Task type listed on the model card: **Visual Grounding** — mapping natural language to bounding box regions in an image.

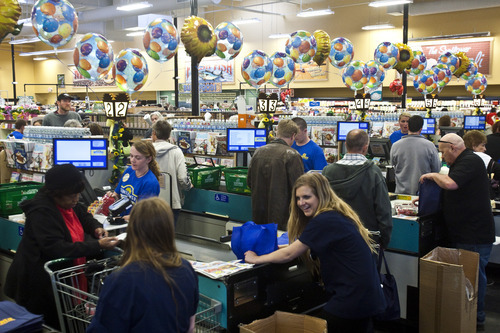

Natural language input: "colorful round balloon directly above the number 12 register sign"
[113,48,149,94]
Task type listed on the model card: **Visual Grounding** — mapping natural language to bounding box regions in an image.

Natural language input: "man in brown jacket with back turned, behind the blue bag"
[247,119,304,230]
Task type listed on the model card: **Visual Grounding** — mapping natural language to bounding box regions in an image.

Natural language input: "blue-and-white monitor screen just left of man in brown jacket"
[227,128,266,152]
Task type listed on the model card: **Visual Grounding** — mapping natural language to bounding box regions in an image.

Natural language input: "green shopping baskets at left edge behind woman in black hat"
[0,182,43,217]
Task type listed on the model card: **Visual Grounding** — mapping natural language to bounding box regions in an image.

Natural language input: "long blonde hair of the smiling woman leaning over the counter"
[287,173,376,272]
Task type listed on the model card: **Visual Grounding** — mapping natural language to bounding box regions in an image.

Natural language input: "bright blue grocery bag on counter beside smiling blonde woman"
[231,221,278,259]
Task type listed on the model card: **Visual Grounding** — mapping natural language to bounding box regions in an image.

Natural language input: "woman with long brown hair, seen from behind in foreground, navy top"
[87,198,199,333]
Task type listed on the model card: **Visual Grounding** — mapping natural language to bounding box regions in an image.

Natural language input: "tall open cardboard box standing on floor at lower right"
[419,247,479,333]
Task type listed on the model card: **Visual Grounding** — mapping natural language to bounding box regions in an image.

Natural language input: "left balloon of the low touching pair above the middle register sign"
[241,50,273,88]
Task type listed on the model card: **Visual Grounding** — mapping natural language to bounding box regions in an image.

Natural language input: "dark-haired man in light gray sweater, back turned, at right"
[391,116,441,195]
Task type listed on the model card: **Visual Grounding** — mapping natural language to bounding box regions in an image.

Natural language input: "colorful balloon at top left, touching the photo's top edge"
[31,0,78,48]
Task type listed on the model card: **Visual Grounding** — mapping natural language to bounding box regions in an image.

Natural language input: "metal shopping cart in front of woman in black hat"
[45,257,225,333]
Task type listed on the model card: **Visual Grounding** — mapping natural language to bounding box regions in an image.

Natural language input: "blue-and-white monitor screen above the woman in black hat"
[53,138,108,170]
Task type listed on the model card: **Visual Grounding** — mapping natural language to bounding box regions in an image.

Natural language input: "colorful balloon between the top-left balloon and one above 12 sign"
[73,33,114,81]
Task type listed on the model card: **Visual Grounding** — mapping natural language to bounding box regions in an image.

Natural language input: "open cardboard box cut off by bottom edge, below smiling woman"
[240,311,327,333]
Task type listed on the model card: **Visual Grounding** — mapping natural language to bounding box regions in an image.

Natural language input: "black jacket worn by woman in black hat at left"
[5,190,102,327]
